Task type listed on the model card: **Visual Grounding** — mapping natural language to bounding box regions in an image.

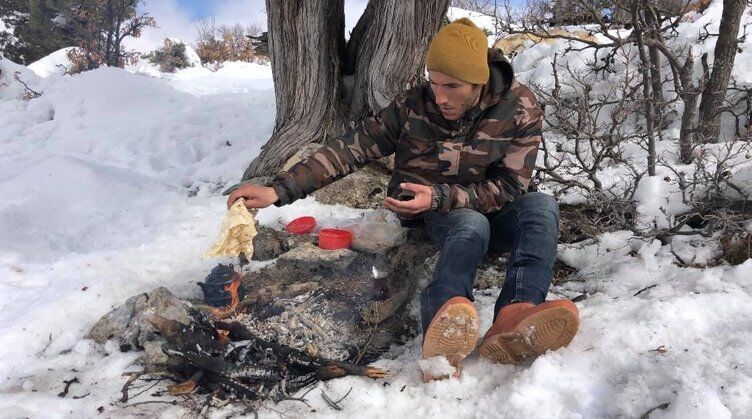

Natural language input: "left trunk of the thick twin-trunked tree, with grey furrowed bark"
[243,0,345,179]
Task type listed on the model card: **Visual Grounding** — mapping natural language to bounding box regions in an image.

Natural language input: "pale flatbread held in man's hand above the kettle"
[204,198,258,260]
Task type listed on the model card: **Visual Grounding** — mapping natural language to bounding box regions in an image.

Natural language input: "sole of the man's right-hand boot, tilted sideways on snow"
[478,307,580,364]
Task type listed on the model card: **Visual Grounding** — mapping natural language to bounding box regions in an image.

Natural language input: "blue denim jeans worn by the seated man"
[420,192,559,331]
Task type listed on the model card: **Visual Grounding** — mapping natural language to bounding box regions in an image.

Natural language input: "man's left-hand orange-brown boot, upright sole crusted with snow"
[420,297,478,382]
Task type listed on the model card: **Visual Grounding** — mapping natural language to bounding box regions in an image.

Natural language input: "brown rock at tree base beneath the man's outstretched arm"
[313,162,391,209]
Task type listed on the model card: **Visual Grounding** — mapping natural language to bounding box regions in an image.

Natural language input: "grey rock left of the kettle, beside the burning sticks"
[89,287,191,350]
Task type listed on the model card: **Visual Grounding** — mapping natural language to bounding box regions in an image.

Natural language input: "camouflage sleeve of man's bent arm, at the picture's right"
[431,92,543,213]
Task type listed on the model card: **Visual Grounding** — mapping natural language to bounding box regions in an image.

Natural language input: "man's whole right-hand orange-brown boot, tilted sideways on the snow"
[478,300,580,364]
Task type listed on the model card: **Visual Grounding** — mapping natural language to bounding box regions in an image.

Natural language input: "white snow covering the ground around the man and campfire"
[0,1,752,418]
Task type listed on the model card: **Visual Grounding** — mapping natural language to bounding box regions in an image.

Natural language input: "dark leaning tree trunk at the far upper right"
[698,0,747,142]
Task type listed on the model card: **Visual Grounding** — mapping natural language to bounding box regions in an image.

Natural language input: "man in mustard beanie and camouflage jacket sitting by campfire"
[227,18,579,381]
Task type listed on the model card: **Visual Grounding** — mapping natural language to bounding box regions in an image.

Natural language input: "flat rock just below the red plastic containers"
[277,243,357,275]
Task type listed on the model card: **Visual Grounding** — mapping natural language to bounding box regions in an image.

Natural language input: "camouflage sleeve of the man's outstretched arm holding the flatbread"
[270,95,407,206]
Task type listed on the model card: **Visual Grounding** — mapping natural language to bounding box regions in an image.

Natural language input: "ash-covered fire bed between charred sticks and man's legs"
[233,229,436,363]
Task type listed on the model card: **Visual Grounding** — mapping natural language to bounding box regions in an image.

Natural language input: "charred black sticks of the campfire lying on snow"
[150,312,386,401]
